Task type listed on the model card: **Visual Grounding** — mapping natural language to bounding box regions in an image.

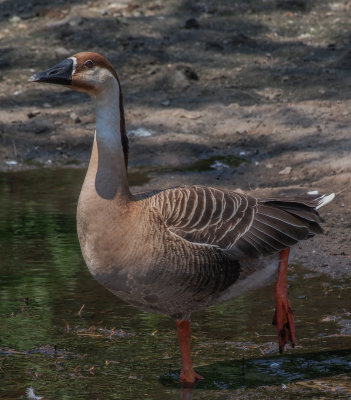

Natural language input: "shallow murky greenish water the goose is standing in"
[0,169,351,400]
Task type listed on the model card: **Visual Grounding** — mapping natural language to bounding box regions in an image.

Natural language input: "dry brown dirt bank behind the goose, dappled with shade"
[0,0,351,277]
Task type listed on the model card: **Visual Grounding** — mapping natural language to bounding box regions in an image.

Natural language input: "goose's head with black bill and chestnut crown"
[29,52,119,97]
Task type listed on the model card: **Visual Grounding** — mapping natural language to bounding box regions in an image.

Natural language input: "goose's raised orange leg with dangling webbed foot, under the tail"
[273,249,295,353]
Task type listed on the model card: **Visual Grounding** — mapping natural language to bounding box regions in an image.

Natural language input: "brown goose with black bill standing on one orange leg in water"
[29,52,334,384]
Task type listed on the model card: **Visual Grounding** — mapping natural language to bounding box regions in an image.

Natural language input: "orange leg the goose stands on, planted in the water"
[176,321,204,383]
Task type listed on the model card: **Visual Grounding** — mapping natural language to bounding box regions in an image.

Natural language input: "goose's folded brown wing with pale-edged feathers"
[150,186,322,259]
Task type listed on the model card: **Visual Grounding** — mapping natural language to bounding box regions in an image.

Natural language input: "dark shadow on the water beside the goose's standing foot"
[161,350,351,390]
